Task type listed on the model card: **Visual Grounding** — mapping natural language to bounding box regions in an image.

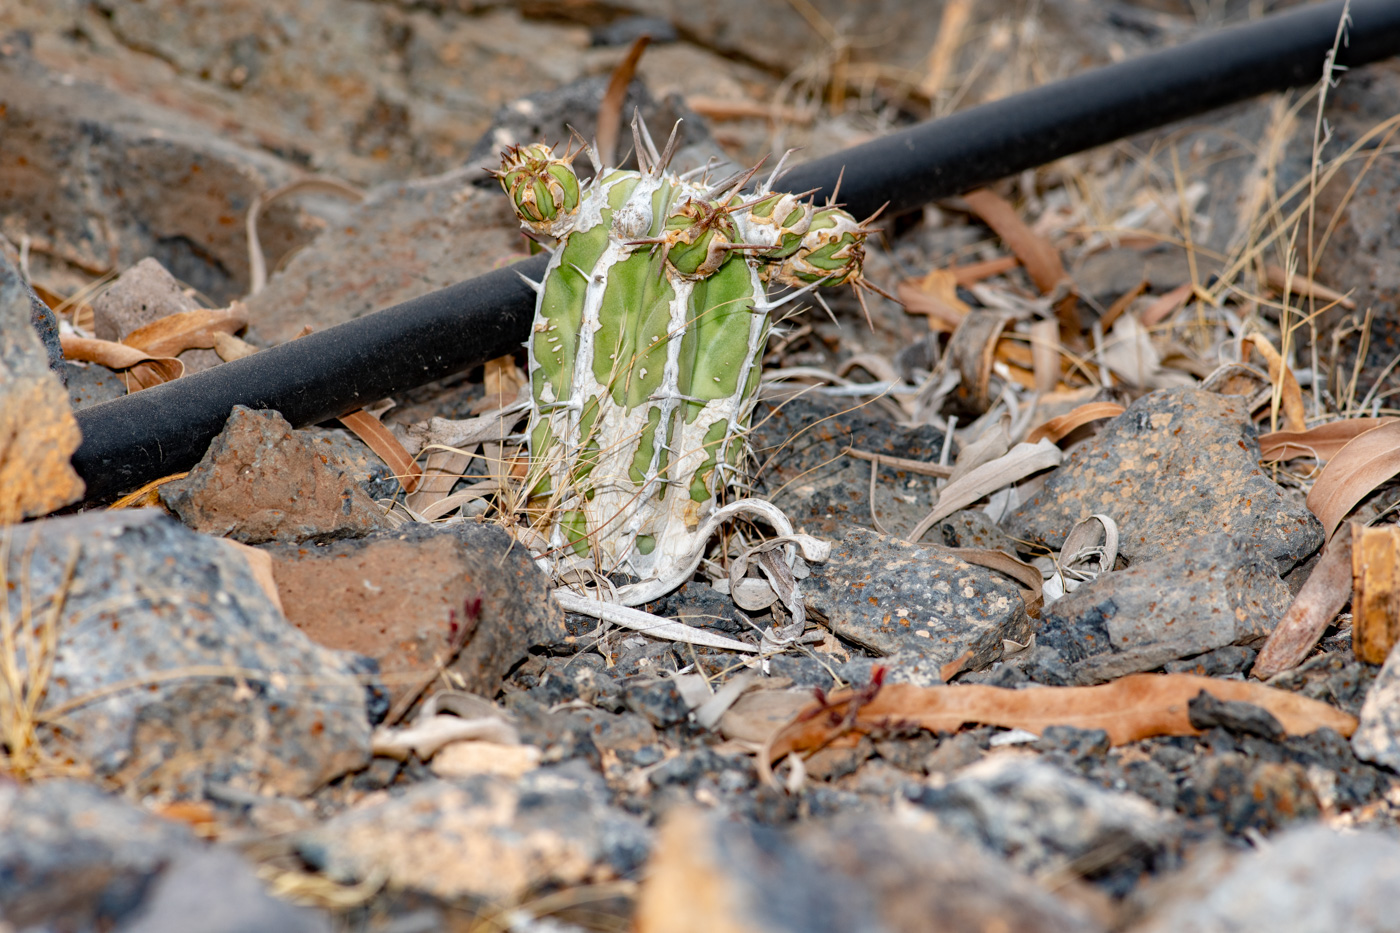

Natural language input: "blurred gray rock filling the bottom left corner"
[0,780,330,933]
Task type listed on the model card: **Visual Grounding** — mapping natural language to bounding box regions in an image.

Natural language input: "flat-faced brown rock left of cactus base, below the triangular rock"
[272,524,564,699]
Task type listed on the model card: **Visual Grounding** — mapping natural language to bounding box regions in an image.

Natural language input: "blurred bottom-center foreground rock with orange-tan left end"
[637,808,1102,933]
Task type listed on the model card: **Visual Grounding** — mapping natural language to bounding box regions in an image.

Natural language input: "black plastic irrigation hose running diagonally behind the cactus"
[73,0,1400,499]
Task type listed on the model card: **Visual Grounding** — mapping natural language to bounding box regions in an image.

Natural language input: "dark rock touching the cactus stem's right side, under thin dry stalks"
[749,395,944,537]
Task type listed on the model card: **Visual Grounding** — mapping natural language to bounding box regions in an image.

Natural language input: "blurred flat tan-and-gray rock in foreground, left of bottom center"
[294,762,650,904]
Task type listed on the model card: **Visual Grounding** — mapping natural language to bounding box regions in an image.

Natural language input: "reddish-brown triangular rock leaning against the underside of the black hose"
[161,405,388,544]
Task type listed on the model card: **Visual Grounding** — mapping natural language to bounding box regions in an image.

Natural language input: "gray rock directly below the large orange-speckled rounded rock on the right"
[1032,534,1291,684]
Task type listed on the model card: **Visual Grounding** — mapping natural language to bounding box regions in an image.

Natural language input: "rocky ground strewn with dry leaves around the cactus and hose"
[0,0,1400,933]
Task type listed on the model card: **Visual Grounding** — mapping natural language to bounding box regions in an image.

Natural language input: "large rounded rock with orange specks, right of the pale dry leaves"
[1005,388,1322,572]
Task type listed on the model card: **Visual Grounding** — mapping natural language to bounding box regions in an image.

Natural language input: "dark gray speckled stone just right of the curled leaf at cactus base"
[804,528,1030,671]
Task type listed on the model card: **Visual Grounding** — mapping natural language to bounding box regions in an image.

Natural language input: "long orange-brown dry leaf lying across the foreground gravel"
[759,674,1357,786]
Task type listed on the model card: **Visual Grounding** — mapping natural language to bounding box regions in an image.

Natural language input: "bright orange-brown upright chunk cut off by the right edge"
[1330,525,1400,664]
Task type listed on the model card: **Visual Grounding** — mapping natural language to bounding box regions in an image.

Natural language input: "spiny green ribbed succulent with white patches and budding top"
[497,123,868,605]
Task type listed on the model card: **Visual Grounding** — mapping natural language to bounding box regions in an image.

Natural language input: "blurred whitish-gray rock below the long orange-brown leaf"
[913,755,1180,892]
